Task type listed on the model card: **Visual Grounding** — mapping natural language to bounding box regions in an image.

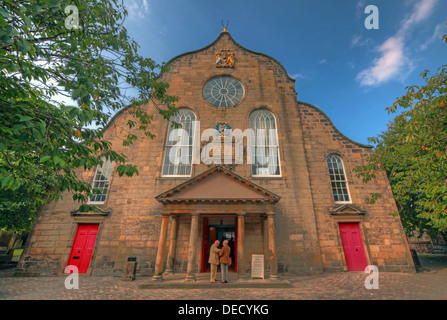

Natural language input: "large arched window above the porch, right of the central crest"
[250,110,281,176]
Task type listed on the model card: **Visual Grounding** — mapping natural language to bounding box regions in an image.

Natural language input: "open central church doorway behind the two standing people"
[201,218,237,272]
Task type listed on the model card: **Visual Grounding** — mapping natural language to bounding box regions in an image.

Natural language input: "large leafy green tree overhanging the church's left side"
[0,0,178,229]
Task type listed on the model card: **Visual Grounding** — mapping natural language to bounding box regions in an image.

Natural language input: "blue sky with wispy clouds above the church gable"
[124,0,447,143]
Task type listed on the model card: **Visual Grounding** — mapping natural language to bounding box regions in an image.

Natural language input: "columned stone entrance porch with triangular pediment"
[153,166,280,282]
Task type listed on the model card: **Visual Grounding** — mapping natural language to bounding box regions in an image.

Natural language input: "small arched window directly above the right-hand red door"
[327,154,351,203]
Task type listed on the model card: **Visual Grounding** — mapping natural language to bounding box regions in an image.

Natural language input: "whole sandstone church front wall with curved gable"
[17,31,414,276]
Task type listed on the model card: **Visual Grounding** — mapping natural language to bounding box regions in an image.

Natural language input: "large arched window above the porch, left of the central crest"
[162,109,196,176]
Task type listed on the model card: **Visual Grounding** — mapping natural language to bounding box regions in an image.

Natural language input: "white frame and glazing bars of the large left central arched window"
[161,108,197,178]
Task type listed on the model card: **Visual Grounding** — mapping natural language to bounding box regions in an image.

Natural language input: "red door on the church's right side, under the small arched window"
[339,223,368,271]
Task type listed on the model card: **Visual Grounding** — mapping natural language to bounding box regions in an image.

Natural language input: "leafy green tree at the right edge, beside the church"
[355,30,447,236]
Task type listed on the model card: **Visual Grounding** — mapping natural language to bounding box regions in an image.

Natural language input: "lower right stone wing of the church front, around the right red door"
[299,103,414,272]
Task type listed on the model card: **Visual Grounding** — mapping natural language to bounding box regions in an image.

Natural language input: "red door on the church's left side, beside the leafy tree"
[68,224,99,273]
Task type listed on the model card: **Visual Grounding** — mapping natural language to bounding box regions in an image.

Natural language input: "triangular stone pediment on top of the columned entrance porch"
[155,165,281,203]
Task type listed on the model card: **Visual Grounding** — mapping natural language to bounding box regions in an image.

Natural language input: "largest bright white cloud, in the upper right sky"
[351,0,439,86]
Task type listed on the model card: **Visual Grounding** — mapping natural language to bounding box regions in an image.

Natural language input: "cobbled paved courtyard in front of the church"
[0,257,447,300]
